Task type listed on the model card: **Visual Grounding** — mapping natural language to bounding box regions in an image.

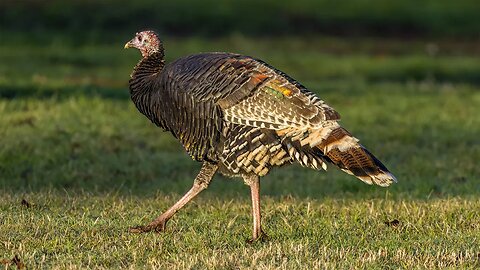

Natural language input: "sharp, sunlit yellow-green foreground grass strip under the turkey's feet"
[0,191,480,269]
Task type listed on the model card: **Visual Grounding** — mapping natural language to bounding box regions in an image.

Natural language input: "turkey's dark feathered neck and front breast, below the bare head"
[129,49,170,130]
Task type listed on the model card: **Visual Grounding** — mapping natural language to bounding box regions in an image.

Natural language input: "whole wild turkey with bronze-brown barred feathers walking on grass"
[125,31,396,241]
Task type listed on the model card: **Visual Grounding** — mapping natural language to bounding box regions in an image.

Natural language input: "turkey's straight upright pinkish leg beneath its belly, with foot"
[243,175,266,243]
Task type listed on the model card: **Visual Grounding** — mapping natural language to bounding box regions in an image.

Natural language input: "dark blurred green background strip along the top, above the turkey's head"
[0,0,480,41]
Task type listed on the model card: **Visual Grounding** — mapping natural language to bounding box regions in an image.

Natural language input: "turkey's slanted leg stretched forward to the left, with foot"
[130,162,218,233]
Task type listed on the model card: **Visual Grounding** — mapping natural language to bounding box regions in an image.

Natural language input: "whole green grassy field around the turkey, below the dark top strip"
[0,37,480,269]
